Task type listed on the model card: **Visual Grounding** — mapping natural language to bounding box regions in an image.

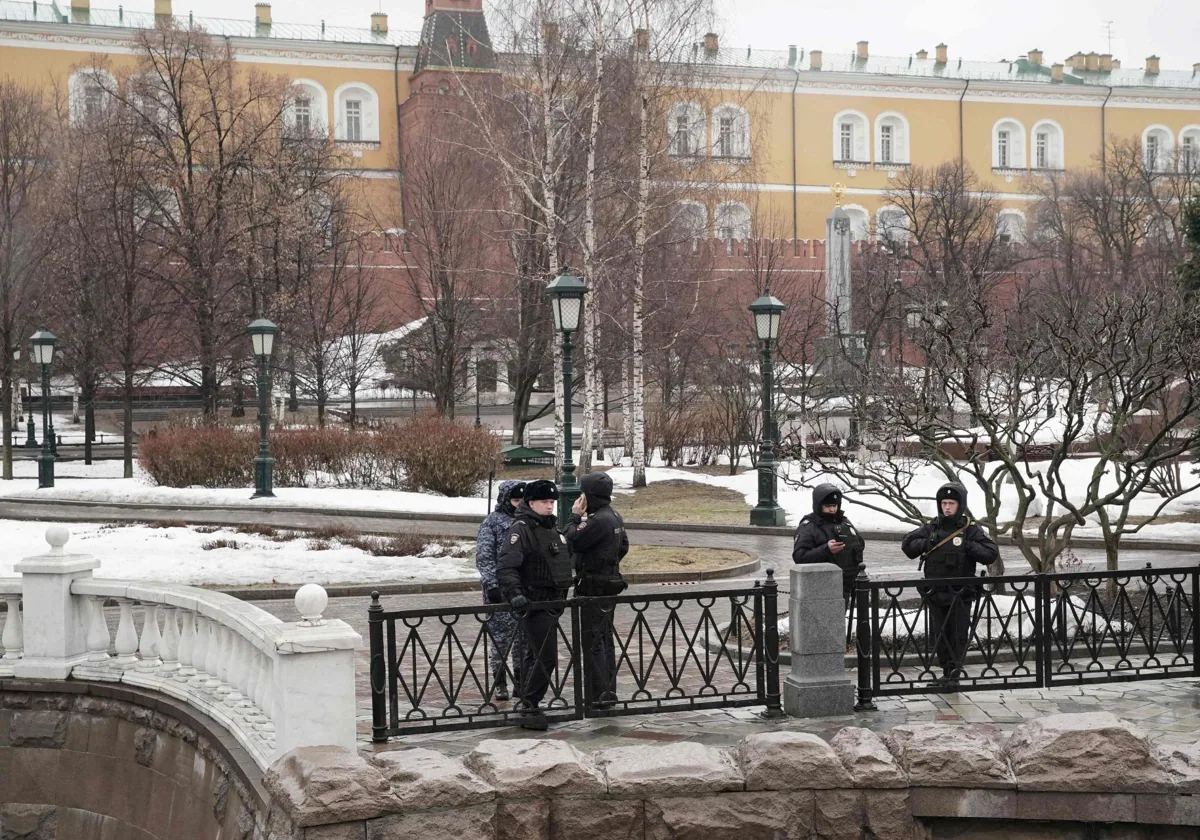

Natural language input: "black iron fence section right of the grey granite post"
[847,565,1200,708]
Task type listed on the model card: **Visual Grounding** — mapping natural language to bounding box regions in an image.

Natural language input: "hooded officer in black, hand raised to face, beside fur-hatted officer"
[563,473,629,709]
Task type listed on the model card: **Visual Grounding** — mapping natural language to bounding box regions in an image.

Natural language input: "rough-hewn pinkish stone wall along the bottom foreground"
[264,713,1200,840]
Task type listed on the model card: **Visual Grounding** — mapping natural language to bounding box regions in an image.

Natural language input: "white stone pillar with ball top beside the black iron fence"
[265,583,362,758]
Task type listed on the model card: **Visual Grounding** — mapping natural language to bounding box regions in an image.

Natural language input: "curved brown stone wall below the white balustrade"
[0,680,290,840]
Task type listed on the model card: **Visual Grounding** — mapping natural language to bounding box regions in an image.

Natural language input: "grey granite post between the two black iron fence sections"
[784,563,854,718]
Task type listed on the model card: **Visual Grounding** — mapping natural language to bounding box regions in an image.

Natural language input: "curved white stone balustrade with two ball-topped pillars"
[0,526,362,768]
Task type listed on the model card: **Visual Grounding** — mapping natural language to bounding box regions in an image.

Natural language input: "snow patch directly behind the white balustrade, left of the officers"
[0,521,479,586]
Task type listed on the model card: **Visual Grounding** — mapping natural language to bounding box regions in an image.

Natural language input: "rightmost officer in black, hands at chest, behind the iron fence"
[901,481,1000,689]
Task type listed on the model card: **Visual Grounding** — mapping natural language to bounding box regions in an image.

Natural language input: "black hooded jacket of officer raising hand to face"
[563,473,629,595]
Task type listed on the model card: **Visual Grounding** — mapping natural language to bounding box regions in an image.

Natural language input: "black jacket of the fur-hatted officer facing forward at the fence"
[496,499,571,601]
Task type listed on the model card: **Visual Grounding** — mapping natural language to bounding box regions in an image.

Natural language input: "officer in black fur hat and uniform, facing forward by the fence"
[496,479,571,730]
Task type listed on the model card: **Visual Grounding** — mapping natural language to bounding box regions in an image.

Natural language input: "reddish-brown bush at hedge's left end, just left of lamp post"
[138,425,258,487]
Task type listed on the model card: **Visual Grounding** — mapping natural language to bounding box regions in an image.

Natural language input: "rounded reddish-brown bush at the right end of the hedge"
[392,415,500,496]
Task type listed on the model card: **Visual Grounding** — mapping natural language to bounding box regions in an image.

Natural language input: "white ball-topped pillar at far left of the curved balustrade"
[13,526,100,679]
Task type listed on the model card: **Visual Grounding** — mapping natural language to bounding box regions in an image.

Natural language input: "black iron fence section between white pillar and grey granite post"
[368,570,781,742]
